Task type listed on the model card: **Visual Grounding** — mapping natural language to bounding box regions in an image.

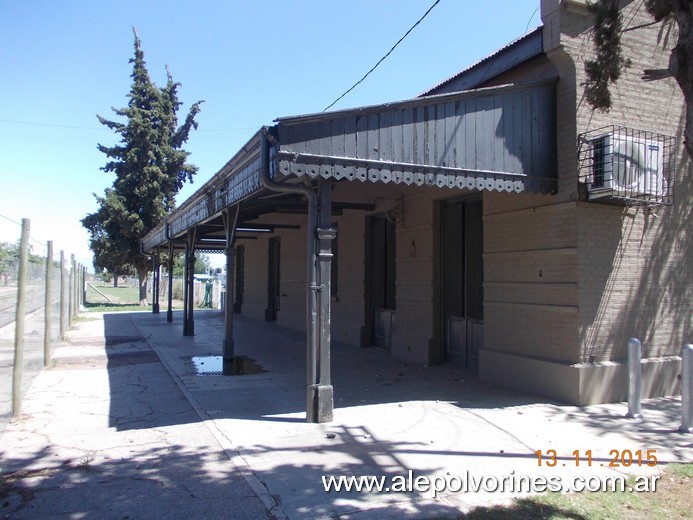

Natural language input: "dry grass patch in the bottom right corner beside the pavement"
[459,464,693,520]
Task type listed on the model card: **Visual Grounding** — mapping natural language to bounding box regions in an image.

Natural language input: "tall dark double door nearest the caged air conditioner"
[440,196,484,372]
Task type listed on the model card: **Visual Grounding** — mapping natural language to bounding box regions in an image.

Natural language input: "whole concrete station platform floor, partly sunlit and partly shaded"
[0,311,693,519]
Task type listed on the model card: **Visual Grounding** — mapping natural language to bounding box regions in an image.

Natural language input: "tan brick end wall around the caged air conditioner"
[550,2,693,361]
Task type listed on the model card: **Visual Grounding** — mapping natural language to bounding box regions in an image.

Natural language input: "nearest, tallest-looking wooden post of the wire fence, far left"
[12,218,31,417]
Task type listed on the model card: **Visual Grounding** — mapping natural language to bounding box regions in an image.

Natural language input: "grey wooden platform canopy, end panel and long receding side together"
[142,81,557,252]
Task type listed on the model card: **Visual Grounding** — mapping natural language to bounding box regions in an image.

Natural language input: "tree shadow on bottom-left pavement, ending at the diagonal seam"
[0,445,268,519]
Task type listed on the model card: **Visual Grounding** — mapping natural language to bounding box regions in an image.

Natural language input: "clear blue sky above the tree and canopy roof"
[0,0,541,270]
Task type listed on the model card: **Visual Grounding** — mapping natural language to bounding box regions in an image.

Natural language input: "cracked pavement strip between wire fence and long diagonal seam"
[0,314,270,519]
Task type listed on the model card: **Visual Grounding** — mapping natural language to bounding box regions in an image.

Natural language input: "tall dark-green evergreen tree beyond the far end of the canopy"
[82,30,202,305]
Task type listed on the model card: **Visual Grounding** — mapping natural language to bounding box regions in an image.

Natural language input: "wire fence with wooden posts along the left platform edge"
[0,219,86,433]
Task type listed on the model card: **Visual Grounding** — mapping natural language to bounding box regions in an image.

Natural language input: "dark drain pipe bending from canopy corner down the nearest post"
[260,127,320,422]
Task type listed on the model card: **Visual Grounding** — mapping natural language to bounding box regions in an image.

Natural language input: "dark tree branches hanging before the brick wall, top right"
[585,0,693,157]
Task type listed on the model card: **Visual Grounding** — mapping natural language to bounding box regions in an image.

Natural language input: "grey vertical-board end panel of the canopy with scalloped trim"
[277,83,556,191]
